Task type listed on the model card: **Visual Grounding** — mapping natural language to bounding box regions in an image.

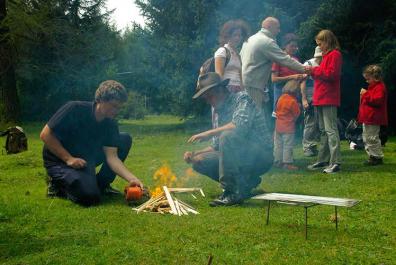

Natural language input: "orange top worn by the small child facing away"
[275,94,300,133]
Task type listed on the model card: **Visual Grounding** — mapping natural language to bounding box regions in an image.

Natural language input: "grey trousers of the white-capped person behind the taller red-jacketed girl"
[302,102,320,151]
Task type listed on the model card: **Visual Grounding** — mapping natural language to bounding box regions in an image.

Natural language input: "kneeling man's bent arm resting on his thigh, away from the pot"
[40,124,87,169]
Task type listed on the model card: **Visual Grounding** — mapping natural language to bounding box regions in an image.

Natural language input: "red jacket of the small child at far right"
[358,82,388,125]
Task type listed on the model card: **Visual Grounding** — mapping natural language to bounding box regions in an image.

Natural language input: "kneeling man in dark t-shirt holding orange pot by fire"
[40,80,143,206]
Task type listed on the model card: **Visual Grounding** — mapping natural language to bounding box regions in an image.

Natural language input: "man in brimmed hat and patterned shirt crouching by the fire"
[184,73,273,207]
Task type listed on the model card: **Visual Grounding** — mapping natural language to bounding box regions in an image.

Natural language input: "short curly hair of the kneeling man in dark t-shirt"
[95,80,128,102]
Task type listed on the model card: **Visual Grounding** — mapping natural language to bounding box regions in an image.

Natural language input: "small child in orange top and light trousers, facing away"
[274,80,300,170]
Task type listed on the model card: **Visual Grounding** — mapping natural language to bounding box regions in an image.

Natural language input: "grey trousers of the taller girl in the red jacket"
[315,106,341,165]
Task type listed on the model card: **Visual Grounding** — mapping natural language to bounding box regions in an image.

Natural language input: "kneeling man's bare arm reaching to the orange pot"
[103,146,143,188]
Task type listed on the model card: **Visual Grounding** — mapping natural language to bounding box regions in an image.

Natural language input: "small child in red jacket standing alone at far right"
[358,65,388,166]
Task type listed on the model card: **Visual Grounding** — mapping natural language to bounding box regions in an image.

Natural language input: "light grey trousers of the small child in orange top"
[274,131,294,164]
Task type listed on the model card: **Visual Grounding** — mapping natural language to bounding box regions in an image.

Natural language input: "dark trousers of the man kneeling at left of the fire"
[46,133,132,206]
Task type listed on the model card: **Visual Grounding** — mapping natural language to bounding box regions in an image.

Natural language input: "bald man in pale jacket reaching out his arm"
[240,17,306,110]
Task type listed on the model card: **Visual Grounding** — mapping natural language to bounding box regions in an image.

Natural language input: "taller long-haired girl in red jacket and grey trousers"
[308,30,342,173]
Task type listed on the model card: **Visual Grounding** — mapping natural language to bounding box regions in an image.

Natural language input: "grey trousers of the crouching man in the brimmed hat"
[193,131,273,193]
